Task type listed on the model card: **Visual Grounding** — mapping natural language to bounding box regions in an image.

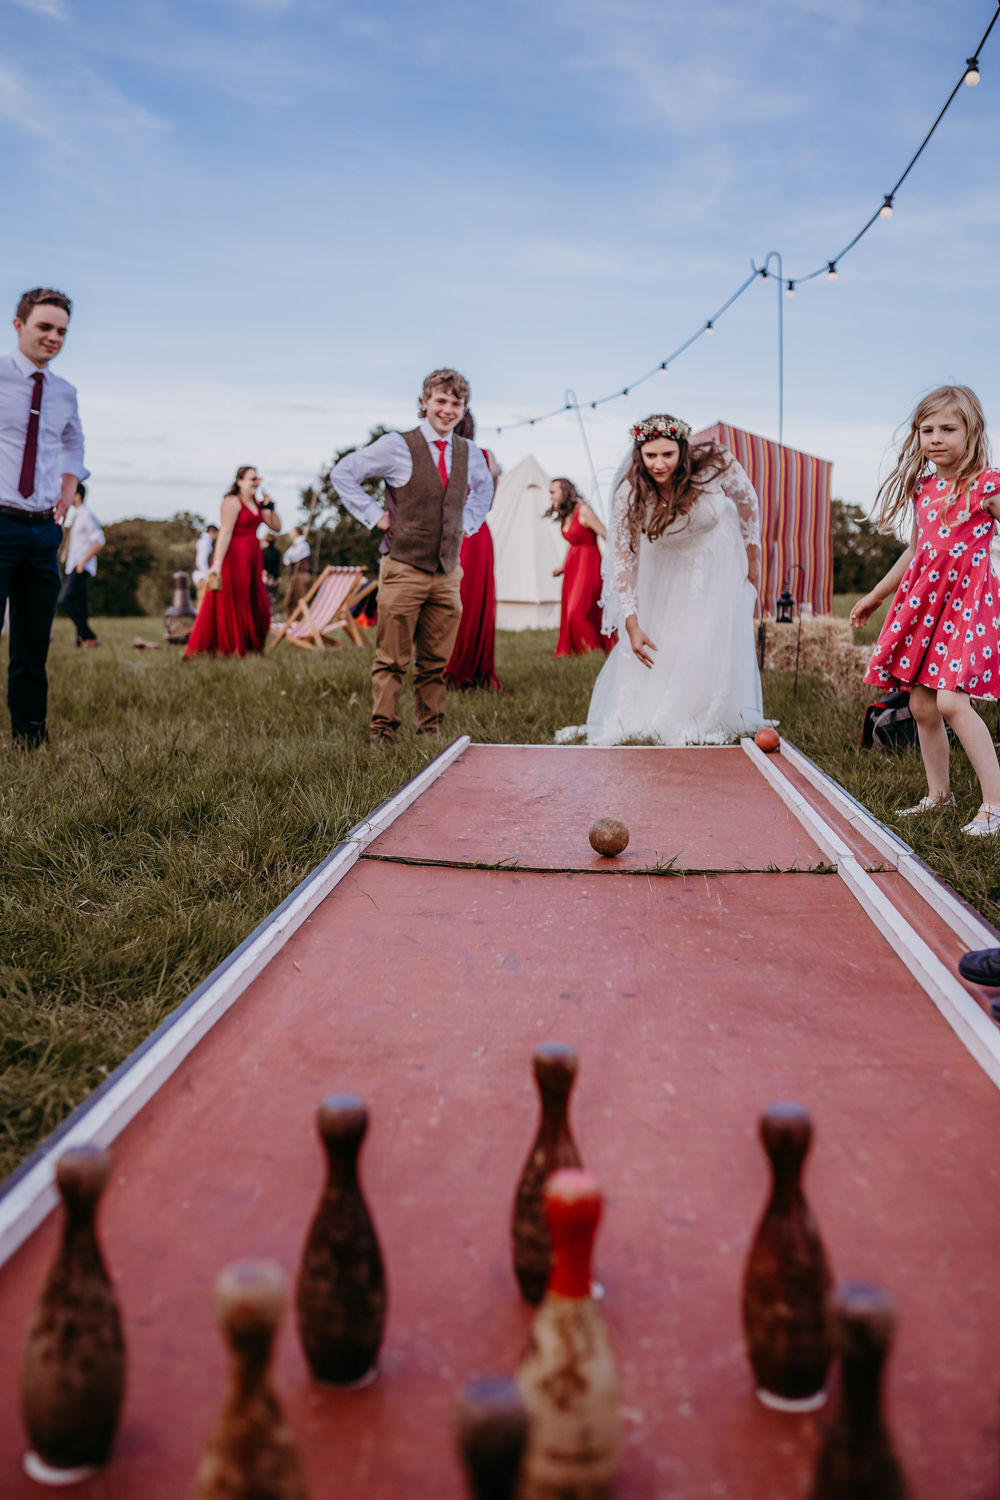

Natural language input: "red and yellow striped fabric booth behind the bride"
[691,422,834,615]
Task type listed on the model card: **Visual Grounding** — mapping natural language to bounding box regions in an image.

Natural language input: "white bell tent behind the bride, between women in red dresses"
[487,455,567,630]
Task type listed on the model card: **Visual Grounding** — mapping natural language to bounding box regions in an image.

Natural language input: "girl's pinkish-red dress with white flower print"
[865,468,1000,698]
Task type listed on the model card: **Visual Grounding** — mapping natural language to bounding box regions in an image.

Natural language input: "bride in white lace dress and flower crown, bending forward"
[556,416,766,746]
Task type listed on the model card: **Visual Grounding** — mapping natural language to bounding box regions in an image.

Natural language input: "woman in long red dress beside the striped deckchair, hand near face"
[184,464,280,657]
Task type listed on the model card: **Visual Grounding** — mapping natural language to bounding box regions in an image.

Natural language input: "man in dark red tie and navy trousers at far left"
[0,287,88,750]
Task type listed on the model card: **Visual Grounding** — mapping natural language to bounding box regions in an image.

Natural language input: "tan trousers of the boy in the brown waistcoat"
[372,557,462,735]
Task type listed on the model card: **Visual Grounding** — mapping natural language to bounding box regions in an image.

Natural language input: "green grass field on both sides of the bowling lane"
[0,603,1000,1173]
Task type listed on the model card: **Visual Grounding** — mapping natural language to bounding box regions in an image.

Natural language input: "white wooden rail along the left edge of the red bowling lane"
[0,735,469,1266]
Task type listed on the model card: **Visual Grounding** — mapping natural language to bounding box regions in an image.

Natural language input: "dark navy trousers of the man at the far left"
[0,515,63,746]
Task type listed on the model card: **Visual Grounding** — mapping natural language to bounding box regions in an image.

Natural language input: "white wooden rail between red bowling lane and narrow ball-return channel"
[742,740,1000,1089]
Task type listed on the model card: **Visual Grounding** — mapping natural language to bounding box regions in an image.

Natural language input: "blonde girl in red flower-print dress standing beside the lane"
[850,386,1000,837]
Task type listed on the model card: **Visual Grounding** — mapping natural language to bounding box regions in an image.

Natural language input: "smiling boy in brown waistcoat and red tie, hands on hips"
[330,369,493,744]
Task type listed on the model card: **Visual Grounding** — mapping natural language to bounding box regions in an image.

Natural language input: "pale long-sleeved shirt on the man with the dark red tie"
[0,350,90,510]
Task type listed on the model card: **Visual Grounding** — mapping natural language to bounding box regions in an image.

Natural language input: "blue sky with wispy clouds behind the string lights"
[0,0,1000,524]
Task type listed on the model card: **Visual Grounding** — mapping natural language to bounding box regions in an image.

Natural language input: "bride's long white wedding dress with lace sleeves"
[556,455,766,746]
